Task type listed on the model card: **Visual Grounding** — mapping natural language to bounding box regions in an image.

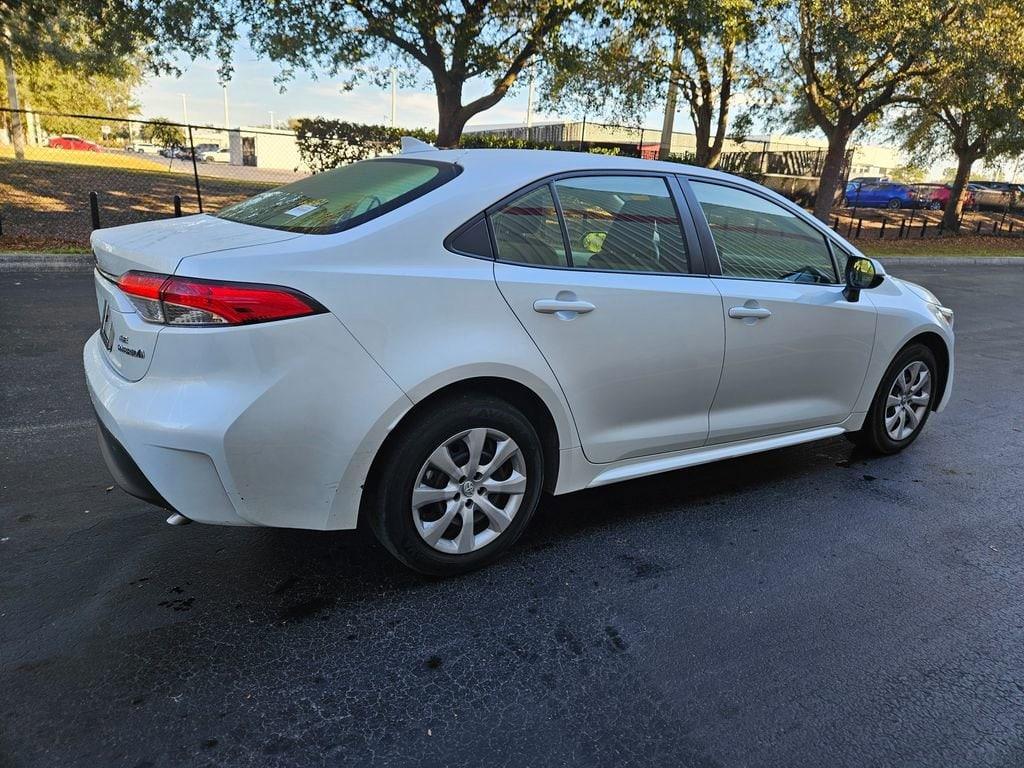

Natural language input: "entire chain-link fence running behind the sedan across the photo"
[0,109,1024,250]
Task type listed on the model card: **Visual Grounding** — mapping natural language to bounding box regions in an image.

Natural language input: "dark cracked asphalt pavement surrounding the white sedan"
[0,266,1024,768]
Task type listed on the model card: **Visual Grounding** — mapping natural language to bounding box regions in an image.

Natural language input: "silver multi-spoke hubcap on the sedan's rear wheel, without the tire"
[413,427,526,555]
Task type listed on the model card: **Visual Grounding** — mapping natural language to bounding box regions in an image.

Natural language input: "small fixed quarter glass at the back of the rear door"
[490,185,567,266]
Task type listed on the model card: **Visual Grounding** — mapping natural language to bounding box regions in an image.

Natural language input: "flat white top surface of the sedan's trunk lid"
[91,214,302,276]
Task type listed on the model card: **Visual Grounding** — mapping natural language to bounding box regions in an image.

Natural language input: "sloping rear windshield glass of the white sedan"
[217,159,461,234]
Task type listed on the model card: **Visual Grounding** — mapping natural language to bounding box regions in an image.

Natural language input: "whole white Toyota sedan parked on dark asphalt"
[85,140,953,574]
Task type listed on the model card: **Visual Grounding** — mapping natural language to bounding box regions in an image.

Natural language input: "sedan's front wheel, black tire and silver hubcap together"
[848,344,938,454]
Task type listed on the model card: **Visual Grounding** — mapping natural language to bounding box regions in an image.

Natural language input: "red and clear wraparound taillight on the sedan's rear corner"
[118,271,327,326]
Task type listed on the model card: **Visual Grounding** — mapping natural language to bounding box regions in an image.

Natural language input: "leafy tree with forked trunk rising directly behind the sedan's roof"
[235,0,595,146]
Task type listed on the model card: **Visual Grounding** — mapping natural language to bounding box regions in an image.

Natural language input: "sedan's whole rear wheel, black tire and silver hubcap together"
[369,395,544,575]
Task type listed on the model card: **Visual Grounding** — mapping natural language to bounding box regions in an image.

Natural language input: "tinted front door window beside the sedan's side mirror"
[690,181,839,283]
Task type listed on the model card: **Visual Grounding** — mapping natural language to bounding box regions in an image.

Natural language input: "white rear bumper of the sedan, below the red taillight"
[83,314,412,529]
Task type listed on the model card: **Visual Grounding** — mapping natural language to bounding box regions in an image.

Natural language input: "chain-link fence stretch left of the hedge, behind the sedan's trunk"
[0,110,309,249]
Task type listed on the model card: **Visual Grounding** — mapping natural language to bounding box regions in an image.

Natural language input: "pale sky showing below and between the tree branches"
[136,43,675,130]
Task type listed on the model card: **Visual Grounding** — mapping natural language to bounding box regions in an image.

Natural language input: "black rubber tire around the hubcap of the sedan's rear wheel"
[367,394,544,577]
